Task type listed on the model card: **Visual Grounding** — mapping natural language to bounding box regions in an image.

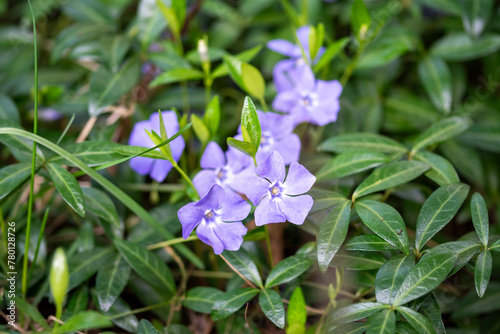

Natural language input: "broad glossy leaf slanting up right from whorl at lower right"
[393,252,457,305]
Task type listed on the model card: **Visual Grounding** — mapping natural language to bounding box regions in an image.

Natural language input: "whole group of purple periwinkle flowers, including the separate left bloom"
[129,27,342,254]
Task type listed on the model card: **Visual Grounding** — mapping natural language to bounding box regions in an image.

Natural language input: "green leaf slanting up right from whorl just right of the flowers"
[352,161,430,199]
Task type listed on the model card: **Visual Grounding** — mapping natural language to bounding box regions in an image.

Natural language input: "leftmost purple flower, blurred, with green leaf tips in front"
[128,111,184,182]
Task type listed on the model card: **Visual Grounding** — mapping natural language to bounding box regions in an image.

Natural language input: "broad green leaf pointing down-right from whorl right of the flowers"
[355,200,410,254]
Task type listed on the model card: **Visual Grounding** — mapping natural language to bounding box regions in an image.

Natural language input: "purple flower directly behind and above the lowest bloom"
[193,142,255,197]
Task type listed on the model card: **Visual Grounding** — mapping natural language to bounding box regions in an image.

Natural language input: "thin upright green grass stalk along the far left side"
[21,0,38,297]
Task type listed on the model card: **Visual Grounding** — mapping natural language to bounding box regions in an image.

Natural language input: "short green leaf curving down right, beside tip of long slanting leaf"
[415,151,460,186]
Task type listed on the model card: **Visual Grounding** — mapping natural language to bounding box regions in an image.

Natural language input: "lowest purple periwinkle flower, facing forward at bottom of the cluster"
[177,185,251,255]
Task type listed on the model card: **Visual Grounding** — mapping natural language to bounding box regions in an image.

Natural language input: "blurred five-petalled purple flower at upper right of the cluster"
[273,67,342,126]
